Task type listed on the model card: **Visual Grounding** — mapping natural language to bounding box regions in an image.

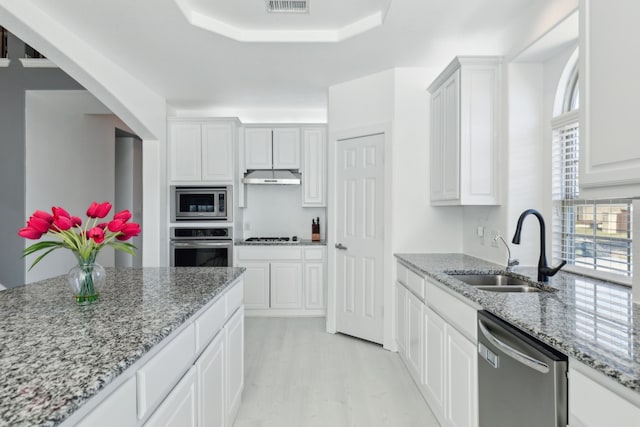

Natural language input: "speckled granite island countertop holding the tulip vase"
[0,267,244,426]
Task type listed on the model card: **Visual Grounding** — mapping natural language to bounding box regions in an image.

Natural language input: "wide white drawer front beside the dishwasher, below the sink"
[426,281,478,344]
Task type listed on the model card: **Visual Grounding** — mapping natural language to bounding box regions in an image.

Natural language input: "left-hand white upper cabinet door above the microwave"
[169,123,202,181]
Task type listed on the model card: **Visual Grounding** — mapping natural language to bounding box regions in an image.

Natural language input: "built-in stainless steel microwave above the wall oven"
[171,187,233,221]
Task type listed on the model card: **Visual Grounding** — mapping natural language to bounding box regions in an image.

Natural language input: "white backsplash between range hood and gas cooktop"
[242,185,327,240]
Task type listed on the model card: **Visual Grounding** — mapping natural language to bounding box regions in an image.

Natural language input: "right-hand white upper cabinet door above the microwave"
[202,123,234,182]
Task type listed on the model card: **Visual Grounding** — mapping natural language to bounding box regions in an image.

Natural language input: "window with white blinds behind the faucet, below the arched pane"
[552,110,632,277]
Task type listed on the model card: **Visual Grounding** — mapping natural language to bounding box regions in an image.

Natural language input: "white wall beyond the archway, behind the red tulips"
[24,91,128,283]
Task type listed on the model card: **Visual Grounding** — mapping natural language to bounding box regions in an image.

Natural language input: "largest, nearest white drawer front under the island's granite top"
[137,324,196,418]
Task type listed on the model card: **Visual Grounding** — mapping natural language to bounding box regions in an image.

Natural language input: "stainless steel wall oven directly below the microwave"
[170,227,233,267]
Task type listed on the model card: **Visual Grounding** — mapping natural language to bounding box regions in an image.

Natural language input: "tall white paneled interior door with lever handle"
[335,134,384,344]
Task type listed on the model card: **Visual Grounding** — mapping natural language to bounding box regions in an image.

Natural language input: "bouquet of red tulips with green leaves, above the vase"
[18,202,141,268]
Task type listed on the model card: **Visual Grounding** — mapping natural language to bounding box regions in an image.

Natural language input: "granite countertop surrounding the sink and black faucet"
[396,254,640,393]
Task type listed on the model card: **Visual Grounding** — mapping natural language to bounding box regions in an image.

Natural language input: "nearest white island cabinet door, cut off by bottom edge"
[145,367,198,427]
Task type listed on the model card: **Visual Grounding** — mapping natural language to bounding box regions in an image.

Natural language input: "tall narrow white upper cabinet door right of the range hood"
[302,128,327,206]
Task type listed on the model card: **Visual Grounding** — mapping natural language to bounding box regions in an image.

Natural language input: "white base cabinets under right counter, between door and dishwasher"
[395,264,478,427]
